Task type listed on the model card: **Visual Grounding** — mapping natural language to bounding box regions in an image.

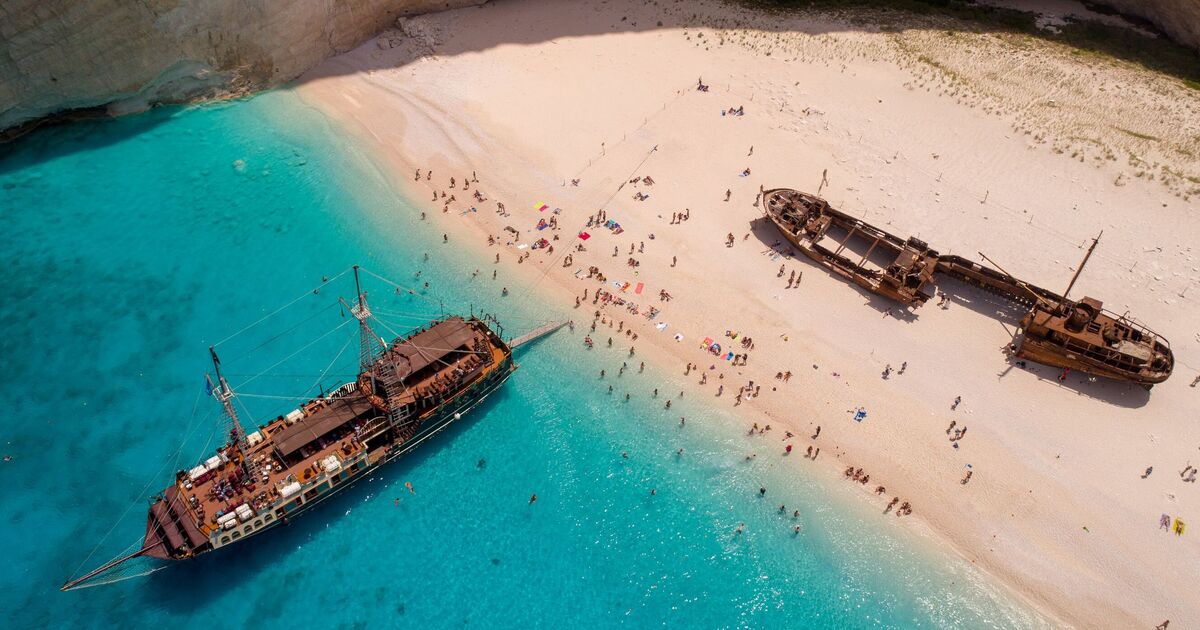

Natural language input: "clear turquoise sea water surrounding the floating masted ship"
[0,91,1044,628]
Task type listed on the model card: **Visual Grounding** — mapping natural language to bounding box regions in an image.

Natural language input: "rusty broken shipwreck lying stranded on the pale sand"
[763,188,1175,389]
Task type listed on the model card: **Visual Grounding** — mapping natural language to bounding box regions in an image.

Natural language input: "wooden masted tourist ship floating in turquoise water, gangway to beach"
[62,266,565,590]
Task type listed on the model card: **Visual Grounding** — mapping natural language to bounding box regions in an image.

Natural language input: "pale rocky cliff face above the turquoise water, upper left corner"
[0,0,485,130]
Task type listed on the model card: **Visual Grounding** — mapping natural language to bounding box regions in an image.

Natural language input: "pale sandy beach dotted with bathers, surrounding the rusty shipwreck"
[298,0,1200,628]
